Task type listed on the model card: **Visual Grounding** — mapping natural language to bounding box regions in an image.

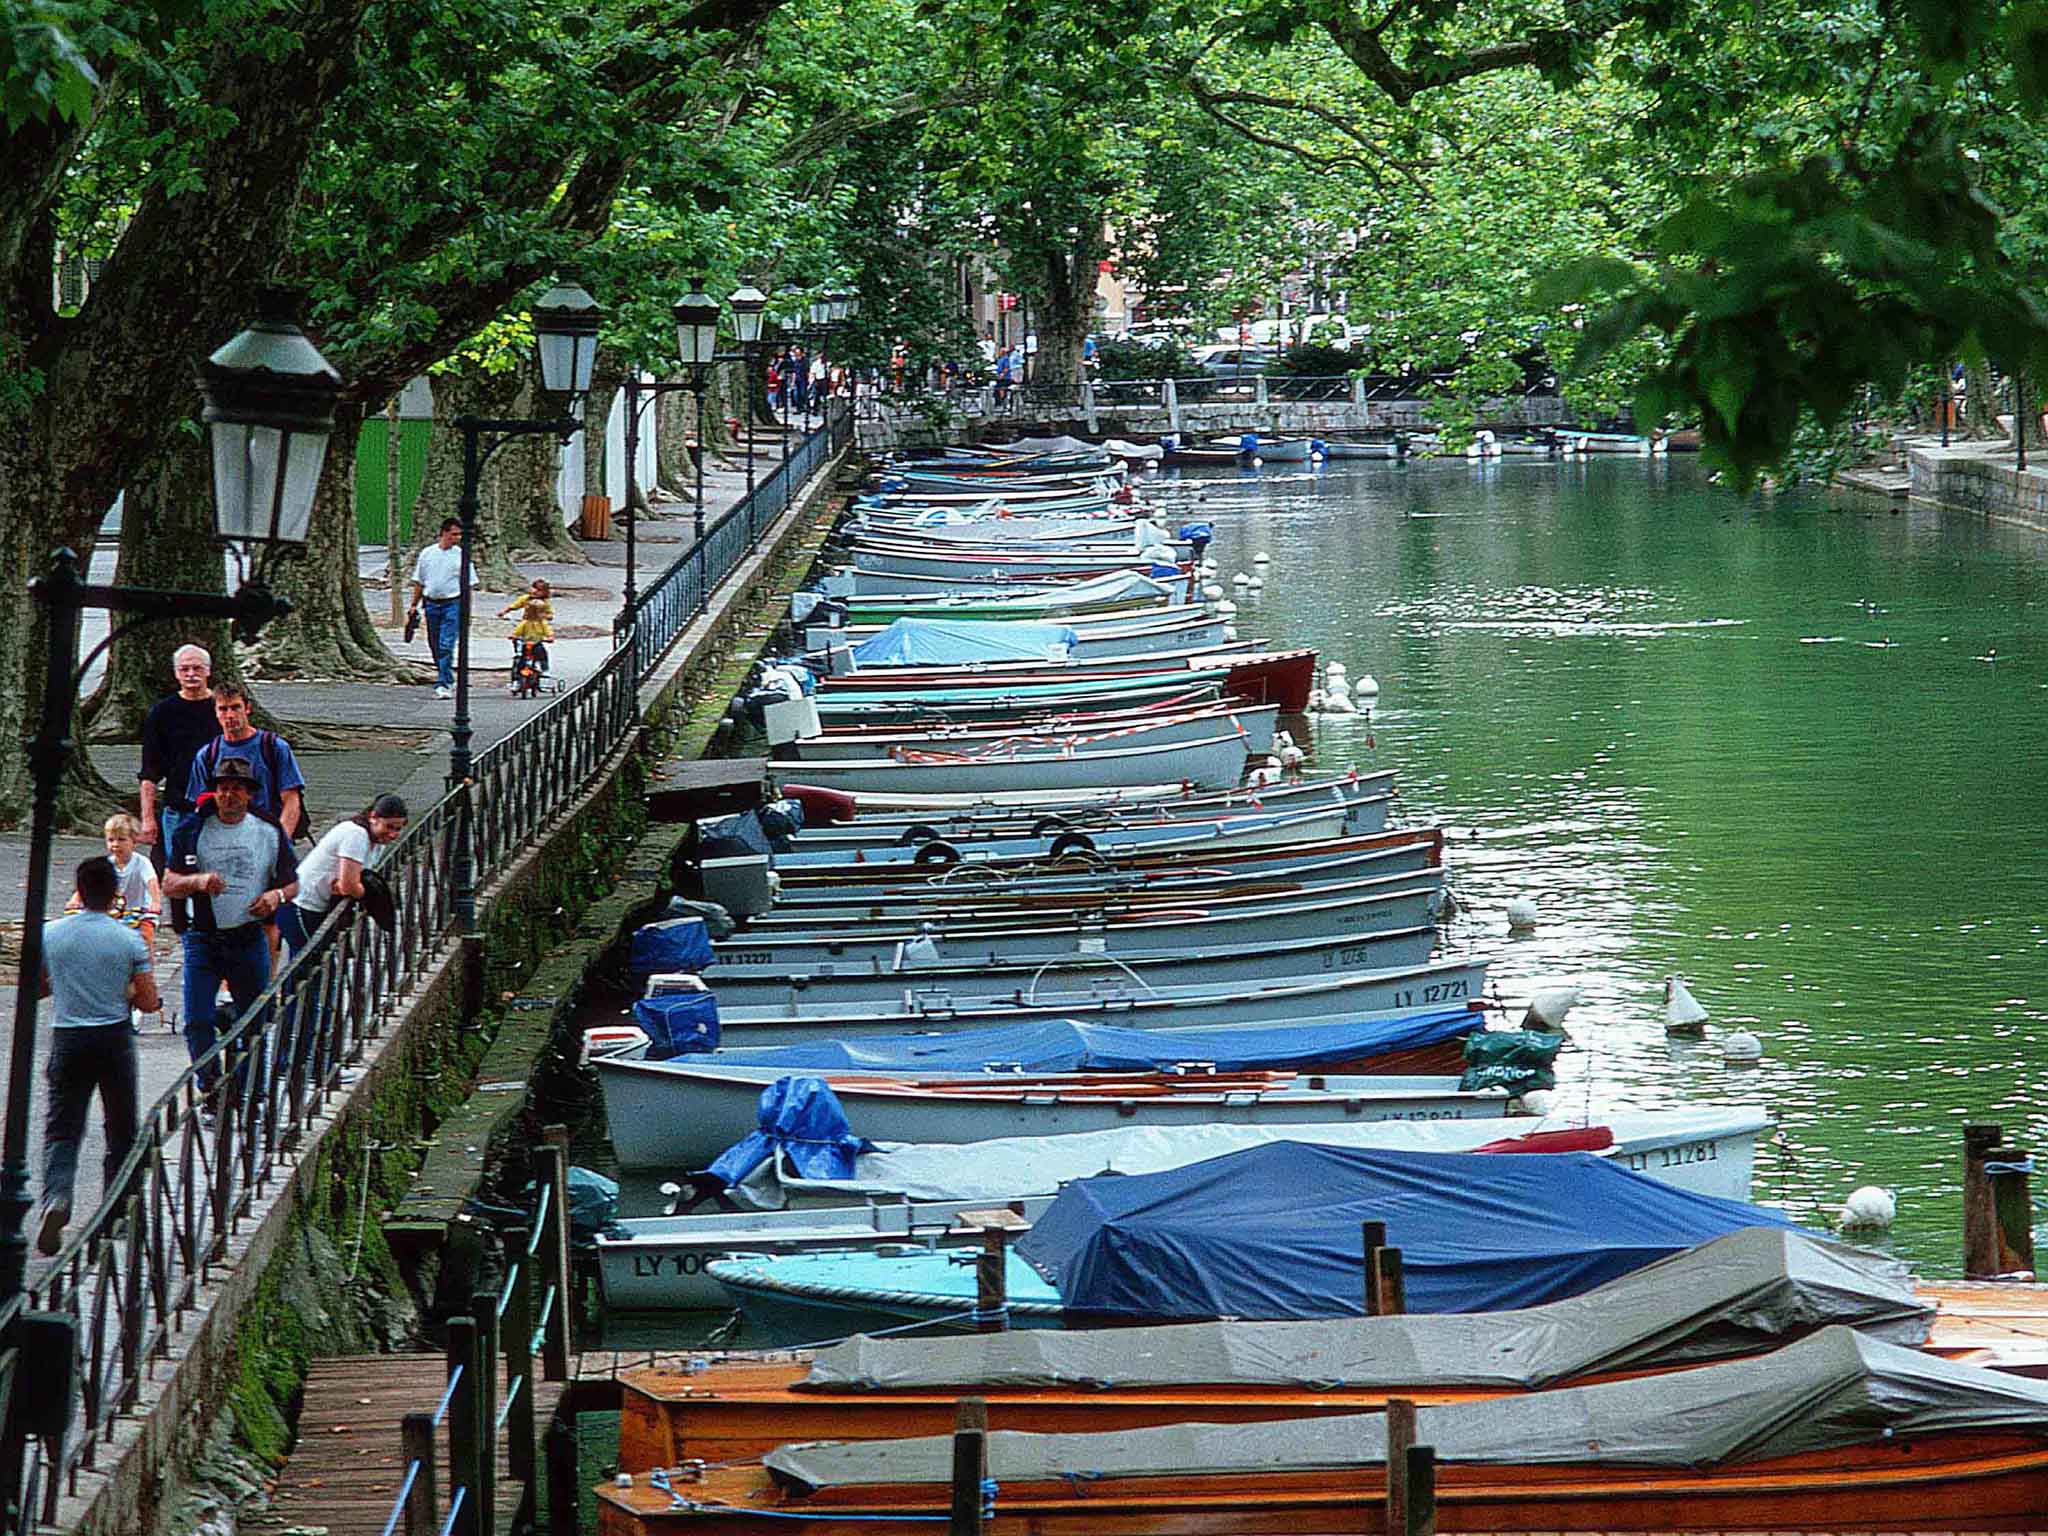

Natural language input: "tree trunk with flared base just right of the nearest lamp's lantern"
[250,401,422,684]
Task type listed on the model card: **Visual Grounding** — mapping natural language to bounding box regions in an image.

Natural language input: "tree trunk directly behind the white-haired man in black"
[80,432,285,741]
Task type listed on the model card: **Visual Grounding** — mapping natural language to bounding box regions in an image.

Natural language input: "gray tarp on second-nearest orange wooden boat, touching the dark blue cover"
[803,1227,1933,1393]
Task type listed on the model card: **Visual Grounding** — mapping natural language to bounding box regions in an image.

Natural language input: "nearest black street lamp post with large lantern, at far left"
[0,289,342,1327]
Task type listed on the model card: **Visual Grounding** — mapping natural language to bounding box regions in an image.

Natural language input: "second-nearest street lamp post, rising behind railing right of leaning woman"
[449,283,604,934]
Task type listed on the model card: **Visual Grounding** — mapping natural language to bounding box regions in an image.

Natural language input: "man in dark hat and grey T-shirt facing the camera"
[164,756,299,1090]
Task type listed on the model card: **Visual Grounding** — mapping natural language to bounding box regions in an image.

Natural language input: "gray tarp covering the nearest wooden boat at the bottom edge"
[762,1327,2048,1487]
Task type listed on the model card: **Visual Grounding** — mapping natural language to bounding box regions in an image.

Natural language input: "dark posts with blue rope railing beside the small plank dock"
[383,1133,569,1536]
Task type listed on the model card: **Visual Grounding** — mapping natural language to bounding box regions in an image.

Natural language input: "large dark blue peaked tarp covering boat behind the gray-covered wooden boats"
[1018,1141,1794,1319]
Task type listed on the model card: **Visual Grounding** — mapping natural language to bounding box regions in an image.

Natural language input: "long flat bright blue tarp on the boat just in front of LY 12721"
[700,1015,1485,1073]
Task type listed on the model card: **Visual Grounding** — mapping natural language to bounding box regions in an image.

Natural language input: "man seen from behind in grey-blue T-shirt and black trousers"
[35,858,160,1255]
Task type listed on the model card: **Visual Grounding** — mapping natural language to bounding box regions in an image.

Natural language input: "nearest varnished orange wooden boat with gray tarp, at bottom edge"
[598,1325,2048,1536]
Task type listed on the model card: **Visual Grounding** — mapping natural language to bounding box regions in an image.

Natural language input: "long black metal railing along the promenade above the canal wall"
[0,401,852,1536]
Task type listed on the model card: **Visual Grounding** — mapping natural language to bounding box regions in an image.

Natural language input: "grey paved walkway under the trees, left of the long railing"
[0,436,798,1278]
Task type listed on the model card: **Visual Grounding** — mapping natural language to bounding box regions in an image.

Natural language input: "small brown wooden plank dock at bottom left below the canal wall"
[244,1354,563,1536]
